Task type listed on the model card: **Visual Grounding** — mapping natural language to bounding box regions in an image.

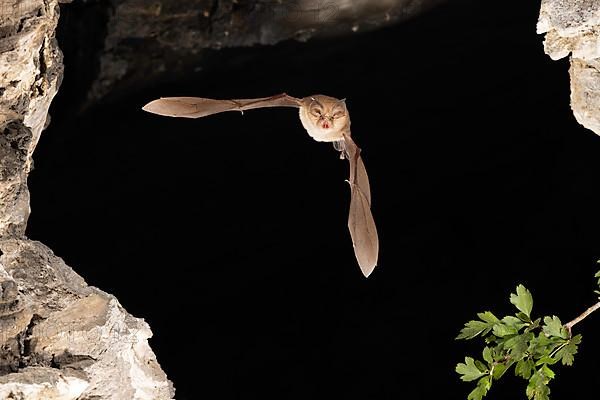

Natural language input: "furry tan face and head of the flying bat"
[300,95,350,142]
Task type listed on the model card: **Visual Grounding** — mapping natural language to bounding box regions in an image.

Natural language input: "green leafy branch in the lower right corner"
[456,271,600,400]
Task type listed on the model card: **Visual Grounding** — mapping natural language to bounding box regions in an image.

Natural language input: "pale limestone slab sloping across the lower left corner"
[0,239,174,400]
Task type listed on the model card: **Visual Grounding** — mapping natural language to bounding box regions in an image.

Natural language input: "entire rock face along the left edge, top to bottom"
[0,0,174,400]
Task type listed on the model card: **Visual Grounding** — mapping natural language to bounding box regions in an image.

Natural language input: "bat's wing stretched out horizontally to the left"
[142,93,301,118]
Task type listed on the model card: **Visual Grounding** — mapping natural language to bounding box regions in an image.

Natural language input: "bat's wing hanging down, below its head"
[344,134,379,277]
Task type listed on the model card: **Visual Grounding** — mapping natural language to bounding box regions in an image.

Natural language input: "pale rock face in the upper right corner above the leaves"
[537,0,600,135]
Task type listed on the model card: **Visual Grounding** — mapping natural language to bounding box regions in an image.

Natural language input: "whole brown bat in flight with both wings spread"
[143,93,379,277]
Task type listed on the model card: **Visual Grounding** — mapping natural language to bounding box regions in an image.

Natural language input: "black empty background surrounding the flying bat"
[28,0,600,400]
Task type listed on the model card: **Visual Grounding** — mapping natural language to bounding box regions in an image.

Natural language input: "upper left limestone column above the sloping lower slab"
[0,0,63,236]
